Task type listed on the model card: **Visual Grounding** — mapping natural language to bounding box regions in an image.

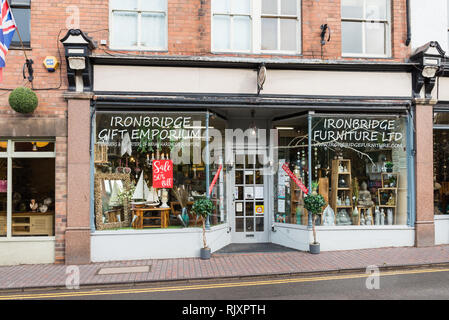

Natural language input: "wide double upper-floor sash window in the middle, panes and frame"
[212,0,301,54]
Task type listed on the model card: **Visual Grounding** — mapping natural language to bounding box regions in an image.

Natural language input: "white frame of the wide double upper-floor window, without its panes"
[211,0,302,56]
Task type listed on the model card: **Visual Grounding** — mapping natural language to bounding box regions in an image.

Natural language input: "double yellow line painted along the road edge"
[0,269,449,300]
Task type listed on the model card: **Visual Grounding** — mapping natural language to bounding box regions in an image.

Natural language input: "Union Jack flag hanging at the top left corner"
[0,0,17,81]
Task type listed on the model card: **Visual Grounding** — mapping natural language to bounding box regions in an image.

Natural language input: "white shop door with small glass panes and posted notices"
[228,150,269,243]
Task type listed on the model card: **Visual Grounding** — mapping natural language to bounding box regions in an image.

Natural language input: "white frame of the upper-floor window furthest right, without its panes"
[340,0,392,58]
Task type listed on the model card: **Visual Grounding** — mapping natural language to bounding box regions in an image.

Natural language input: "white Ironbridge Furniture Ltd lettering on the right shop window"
[312,117,404,148]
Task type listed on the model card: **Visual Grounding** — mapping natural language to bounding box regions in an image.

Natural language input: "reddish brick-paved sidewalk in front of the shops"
[0,245,449,289]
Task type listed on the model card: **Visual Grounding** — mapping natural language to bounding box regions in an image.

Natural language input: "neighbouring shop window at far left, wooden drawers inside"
[0,140,55,237]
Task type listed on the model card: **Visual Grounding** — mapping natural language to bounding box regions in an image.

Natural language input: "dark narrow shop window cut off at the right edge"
[433,112,449,214]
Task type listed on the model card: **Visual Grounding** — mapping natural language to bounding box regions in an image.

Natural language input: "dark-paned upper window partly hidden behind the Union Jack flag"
[9,0,31,48]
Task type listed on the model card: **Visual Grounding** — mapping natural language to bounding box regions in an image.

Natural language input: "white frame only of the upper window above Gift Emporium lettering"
[109,0,168,52]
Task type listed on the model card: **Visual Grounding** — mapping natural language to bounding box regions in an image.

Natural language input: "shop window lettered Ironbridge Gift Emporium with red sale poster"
[94,111,226,230]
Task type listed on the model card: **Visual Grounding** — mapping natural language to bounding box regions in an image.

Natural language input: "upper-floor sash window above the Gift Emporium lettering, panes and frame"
[110,0,167,50]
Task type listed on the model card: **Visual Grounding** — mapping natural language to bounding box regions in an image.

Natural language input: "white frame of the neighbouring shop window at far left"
[0,137,56,242]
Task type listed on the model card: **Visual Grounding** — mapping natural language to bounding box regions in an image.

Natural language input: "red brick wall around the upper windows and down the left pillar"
[0,0,444,263]
